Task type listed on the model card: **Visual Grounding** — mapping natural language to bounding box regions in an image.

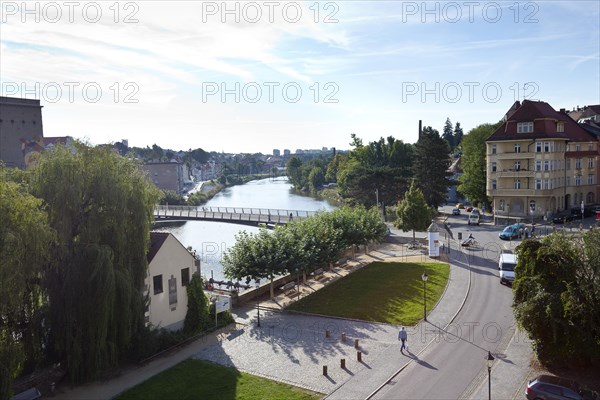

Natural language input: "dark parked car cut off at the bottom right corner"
[525,375,598,400]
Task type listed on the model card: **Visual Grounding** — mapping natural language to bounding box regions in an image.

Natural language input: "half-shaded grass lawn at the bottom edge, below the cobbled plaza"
[117,359,322,400]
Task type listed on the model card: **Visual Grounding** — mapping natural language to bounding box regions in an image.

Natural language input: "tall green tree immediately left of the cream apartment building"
[458,124,496,205]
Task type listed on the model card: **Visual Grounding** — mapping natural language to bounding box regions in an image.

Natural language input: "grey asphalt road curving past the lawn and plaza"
[374,213,518,399]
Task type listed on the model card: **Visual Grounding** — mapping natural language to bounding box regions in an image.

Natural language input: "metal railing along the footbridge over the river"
[154,205,324,223]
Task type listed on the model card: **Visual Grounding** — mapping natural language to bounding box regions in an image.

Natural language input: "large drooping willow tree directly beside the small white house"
[32,145,159,382]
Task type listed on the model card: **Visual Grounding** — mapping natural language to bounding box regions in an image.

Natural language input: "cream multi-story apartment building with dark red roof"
[486,100,600,223]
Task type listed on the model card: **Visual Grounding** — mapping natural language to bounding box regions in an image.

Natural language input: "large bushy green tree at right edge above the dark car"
[513,231,600,365]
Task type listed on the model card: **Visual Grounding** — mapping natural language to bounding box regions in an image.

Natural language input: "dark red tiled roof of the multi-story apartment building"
[487,100,594,141]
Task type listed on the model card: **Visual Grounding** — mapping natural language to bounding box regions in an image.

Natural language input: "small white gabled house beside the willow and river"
[145,232,200,331]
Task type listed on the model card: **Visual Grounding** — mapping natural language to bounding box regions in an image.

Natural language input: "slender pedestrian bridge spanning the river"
[154,205,317,228]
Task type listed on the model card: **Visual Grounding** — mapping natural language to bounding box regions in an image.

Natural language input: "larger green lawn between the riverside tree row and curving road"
[287,262,450,326]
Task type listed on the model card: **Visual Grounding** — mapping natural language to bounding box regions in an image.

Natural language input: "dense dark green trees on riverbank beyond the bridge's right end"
[287,120,454,208]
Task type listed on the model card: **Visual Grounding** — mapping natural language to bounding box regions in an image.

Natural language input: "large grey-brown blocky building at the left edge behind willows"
[0,97,44,168]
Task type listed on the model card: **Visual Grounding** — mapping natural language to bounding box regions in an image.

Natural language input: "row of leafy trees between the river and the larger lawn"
[222,207,388,296]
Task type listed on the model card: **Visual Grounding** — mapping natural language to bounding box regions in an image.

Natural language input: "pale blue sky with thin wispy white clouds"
[0,0,600,154]
